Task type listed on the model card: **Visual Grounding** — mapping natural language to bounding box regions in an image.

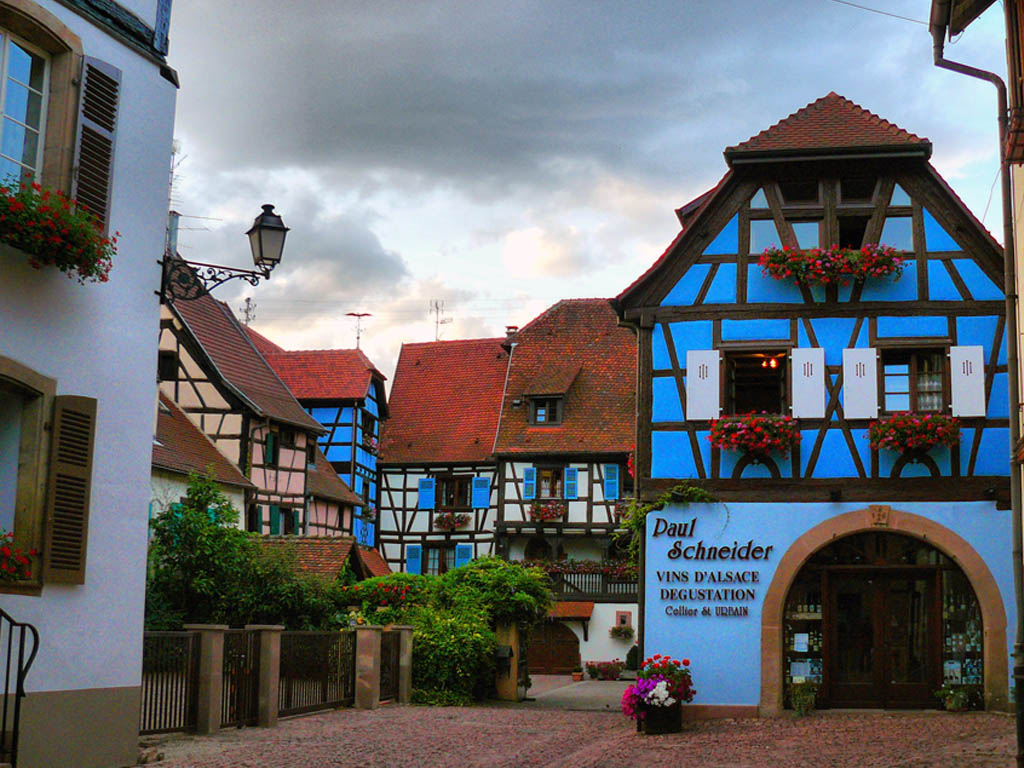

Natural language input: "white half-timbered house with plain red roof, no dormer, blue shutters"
[379,339,509,573]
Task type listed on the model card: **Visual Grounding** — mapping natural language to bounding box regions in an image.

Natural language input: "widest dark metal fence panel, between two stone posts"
[278,632,355,716]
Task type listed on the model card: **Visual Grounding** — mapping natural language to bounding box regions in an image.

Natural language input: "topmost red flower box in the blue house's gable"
[758,245,905,286]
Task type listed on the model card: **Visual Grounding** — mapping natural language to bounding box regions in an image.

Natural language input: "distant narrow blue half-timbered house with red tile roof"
[260,342,387,547]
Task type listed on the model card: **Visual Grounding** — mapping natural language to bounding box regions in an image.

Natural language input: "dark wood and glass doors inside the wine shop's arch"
[782,530,984,709]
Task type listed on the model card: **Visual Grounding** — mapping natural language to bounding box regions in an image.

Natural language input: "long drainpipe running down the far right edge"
[930,6,1024,768]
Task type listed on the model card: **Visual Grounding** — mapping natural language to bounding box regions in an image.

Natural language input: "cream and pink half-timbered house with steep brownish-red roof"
[159,295,337,534]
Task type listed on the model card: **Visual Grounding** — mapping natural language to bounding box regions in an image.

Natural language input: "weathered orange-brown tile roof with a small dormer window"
[496,299,637,454]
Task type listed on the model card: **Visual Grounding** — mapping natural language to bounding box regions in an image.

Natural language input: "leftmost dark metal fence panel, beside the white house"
[139,632,199,733]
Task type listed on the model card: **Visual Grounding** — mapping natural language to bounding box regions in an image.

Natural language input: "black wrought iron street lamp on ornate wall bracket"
[160,204,288,303]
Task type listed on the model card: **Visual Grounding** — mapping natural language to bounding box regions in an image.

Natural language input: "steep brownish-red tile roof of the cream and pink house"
[171,294,324,434]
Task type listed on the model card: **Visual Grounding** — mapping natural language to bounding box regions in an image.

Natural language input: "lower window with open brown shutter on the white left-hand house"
[0,357,96,591]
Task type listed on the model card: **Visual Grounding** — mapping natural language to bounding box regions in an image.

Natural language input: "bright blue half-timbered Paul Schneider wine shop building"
[616,93,1013,714]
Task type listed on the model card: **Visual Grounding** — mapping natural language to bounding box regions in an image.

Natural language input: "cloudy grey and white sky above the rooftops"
[169,0,1006,376]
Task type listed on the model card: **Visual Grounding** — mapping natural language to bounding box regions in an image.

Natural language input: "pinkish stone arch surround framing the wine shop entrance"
[759,506,1009,716]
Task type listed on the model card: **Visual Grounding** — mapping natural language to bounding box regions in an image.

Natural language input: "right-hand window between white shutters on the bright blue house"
[882,349,948,413]
